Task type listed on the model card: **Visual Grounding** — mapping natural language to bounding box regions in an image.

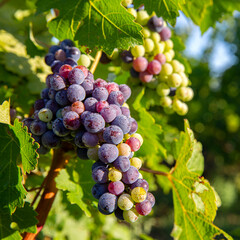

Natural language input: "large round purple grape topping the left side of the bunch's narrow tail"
[98,143,119,164]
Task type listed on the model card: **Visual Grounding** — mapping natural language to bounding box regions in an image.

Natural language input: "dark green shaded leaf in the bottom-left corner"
[0,202,38,239]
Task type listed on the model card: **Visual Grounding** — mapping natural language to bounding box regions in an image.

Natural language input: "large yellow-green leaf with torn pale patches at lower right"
[168,121,232,240]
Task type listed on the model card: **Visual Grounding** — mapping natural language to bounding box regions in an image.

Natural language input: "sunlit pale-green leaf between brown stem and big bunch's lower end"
[55,159,94,217]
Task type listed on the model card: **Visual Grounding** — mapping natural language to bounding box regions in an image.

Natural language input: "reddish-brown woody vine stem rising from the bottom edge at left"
[23,148,68,240]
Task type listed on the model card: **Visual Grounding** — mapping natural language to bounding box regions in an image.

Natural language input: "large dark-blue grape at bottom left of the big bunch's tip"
[98,193,117,214]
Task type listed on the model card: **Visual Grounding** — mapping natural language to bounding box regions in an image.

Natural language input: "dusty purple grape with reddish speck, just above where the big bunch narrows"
[103,125,123,144]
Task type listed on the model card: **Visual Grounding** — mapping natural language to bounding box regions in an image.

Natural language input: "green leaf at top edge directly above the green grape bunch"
[134,0,185,26]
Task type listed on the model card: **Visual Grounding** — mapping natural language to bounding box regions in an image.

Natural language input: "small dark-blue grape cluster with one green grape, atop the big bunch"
[45,39,91,73]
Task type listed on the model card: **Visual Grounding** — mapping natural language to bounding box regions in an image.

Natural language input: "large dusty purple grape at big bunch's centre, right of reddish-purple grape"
[83,113,105,133]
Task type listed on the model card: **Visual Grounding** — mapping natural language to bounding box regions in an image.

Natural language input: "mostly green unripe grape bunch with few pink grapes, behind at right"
[101,4,193,115]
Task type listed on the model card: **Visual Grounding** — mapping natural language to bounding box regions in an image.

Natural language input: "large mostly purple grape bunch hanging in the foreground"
[23,40,155,222]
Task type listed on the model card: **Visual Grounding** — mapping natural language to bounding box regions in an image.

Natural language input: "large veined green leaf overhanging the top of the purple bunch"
[37,0,142,54]
